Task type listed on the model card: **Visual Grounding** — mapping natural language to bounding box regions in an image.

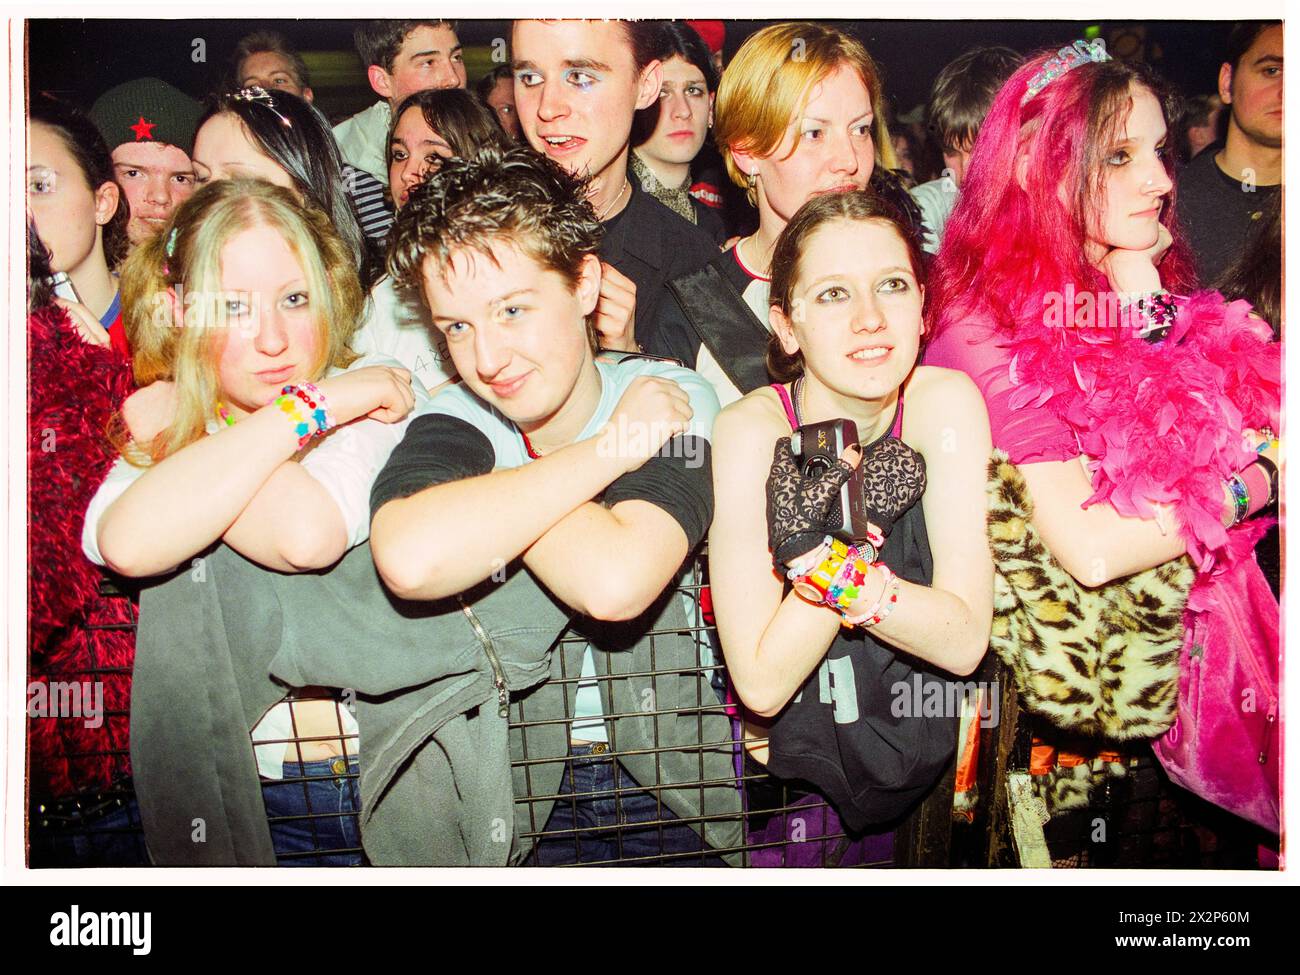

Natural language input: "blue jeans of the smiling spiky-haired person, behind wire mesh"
[529,745,725,867]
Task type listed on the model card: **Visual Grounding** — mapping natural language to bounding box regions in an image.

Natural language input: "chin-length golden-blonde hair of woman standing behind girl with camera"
[714,23,898,205]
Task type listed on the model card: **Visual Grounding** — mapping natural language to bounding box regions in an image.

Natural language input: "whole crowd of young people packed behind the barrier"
[26,20,1283,866]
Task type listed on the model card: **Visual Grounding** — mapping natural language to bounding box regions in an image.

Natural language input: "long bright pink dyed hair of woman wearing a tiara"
[927,51,1196,334]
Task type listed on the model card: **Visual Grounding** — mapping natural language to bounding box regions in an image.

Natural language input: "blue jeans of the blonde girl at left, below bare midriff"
[261,757,364,867]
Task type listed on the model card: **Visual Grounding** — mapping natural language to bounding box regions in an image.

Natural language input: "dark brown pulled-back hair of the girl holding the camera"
[767,190,926,382]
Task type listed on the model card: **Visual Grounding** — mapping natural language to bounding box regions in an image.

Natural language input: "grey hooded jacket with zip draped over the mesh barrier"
[131,545,742,866]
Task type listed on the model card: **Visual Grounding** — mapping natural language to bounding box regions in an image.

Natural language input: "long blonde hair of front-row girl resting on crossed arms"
[114,179,365,465]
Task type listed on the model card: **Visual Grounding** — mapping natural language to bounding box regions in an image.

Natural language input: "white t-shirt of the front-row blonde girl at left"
[82,355,429,779]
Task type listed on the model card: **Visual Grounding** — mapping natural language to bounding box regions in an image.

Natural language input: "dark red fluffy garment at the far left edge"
[27,308,135,798]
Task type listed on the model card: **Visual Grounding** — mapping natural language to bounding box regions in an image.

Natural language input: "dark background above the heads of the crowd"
[27,18,1232,120]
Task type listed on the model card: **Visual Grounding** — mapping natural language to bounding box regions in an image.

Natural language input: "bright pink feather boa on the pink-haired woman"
[1010,291,1282,572]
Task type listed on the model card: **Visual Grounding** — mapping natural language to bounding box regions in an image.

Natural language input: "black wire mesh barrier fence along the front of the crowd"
[29,559,1266,868]
